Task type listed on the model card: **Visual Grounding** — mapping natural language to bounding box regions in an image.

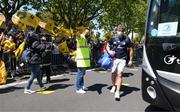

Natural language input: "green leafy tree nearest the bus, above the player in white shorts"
[98,0,147,39]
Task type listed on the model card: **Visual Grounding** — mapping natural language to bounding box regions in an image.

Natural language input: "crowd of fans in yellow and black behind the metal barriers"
[0,26,106,82]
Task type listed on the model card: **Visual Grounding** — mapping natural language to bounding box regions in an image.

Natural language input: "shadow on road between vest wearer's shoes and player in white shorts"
[88,84,107,95]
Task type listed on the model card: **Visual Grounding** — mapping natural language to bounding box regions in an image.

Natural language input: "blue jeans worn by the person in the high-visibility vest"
[76,68,86,90]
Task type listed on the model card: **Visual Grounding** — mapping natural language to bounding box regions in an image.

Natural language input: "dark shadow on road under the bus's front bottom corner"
[144,105,170,112]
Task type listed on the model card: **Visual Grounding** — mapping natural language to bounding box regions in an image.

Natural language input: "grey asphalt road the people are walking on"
[0,67,162,112]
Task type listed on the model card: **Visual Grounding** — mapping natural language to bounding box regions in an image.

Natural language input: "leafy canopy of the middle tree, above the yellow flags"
[34,0,109,28]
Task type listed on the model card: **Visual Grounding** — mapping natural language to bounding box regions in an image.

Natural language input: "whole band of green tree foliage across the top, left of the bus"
[0,0,147,37]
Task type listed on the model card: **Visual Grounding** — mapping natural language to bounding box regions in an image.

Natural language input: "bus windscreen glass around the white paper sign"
[147,0,180,37]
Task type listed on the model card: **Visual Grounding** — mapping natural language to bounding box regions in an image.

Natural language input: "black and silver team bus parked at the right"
[142,0,180,111]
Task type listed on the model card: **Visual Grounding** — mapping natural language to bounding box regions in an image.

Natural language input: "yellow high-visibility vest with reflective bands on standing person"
[76,35,90,67]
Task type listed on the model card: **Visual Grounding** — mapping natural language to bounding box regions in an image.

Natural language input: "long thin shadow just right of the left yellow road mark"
[48,84,74,90]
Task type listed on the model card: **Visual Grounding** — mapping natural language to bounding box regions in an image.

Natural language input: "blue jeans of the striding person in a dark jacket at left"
[26,64,44,89]
